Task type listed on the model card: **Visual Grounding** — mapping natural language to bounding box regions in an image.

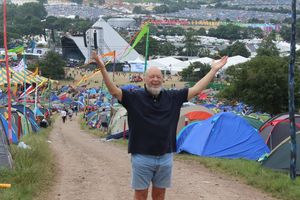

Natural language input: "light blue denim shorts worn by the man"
[131,153,173,190]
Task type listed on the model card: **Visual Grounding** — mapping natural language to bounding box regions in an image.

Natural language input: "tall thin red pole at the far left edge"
[3,0,12,144]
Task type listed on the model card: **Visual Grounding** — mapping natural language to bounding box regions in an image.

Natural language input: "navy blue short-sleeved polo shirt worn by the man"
[121,88,188,155]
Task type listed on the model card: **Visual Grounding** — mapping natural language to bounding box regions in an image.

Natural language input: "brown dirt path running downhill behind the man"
[47,115,272,200]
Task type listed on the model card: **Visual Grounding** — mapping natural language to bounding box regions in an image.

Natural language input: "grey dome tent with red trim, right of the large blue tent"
[259,113,300,150]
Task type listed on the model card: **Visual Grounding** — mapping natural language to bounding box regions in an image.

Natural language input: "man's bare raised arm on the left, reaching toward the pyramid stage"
[92,51,122,101]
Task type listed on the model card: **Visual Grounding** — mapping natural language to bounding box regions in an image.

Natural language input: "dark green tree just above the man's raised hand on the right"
[220,41,251,58]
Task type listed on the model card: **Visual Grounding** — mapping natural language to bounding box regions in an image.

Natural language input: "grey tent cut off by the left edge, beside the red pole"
[0,116,12,168]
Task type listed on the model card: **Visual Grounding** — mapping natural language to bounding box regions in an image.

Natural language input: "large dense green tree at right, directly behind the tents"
[220,56,300,114]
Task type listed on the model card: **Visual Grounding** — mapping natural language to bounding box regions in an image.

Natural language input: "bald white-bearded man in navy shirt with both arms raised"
[92,52,228,200]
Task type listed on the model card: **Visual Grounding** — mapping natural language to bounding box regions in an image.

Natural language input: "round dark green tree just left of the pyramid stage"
[38,51,66,80]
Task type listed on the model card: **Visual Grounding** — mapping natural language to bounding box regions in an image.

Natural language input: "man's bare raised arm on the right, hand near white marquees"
[188,56,228,100]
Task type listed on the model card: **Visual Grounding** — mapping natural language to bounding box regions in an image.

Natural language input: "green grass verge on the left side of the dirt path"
[0,124,55,200]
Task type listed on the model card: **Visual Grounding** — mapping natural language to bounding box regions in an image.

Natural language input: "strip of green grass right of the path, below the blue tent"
[175,154,300,200]
